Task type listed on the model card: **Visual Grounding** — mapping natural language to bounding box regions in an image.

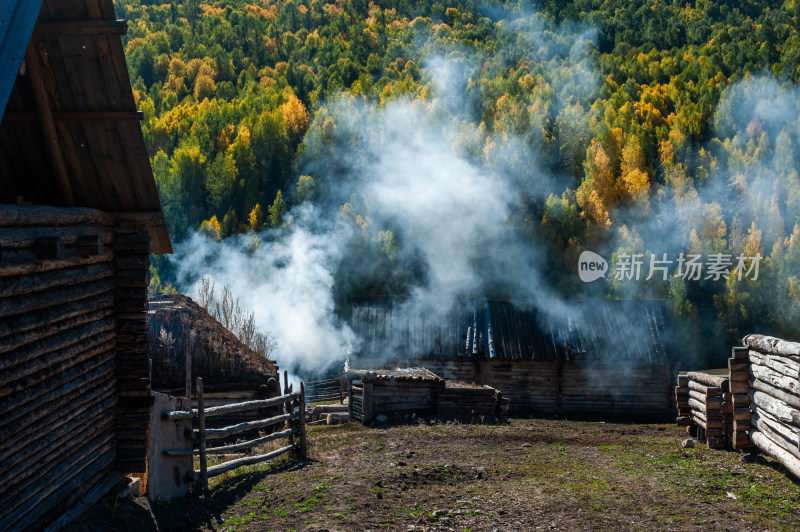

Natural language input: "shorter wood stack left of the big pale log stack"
[675,371,733,449]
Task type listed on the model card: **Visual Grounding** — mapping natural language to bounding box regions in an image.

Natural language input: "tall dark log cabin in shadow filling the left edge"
[0,0,171,530]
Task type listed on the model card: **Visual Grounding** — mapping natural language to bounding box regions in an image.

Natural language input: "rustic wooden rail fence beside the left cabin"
[161,377,308,490]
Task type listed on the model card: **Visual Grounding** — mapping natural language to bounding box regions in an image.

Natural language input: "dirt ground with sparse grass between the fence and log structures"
[67,419,800,531]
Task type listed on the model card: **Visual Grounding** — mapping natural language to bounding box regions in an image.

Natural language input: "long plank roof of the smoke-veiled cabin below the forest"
[351,299,675,362]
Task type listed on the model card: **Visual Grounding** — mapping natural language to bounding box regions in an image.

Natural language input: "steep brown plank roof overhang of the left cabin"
[0,0,172,253]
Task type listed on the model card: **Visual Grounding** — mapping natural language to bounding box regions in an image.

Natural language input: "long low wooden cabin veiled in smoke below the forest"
[351,299,677,418]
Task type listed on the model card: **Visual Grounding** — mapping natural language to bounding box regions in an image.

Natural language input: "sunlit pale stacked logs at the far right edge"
[744,335,800,478]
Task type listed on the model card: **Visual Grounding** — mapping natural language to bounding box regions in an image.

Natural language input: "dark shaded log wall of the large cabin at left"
[0,206,155,530]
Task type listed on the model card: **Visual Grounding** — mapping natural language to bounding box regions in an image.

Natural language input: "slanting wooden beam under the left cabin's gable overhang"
[25,38,75,207]
